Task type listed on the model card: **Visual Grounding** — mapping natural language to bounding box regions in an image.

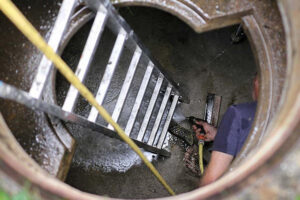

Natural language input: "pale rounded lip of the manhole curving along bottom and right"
[0,0,300,199]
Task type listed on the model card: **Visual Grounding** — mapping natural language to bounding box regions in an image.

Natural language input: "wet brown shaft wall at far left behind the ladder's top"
[0,0,72,176]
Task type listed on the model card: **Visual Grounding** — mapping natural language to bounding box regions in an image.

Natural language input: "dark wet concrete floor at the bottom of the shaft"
[57,7,256,198]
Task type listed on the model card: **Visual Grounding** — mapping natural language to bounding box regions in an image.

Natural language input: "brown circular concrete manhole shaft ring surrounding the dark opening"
[0,0,300,199]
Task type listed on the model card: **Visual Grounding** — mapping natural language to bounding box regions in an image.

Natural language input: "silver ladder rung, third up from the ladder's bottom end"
[137,73,164,141]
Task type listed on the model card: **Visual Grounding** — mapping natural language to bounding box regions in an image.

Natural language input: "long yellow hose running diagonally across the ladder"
[0,0,175,195]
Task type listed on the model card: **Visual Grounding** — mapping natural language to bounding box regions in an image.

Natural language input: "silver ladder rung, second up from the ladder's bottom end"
[148,84,172,146]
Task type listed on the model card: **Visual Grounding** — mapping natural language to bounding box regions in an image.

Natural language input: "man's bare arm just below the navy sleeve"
[199,151,233,187]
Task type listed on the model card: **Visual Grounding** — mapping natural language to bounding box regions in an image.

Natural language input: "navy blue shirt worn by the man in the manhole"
[212,102,256,157]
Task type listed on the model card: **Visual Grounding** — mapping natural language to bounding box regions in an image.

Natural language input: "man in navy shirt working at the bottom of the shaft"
[193,75,259,187]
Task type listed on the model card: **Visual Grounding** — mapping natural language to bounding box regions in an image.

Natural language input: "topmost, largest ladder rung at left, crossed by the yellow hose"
[29,0,77,99]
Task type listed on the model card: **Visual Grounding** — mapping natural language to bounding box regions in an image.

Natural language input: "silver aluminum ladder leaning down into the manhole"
[0,0,185,156]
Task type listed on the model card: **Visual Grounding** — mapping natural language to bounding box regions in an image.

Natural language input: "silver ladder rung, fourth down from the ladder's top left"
[108,46,142,129]
